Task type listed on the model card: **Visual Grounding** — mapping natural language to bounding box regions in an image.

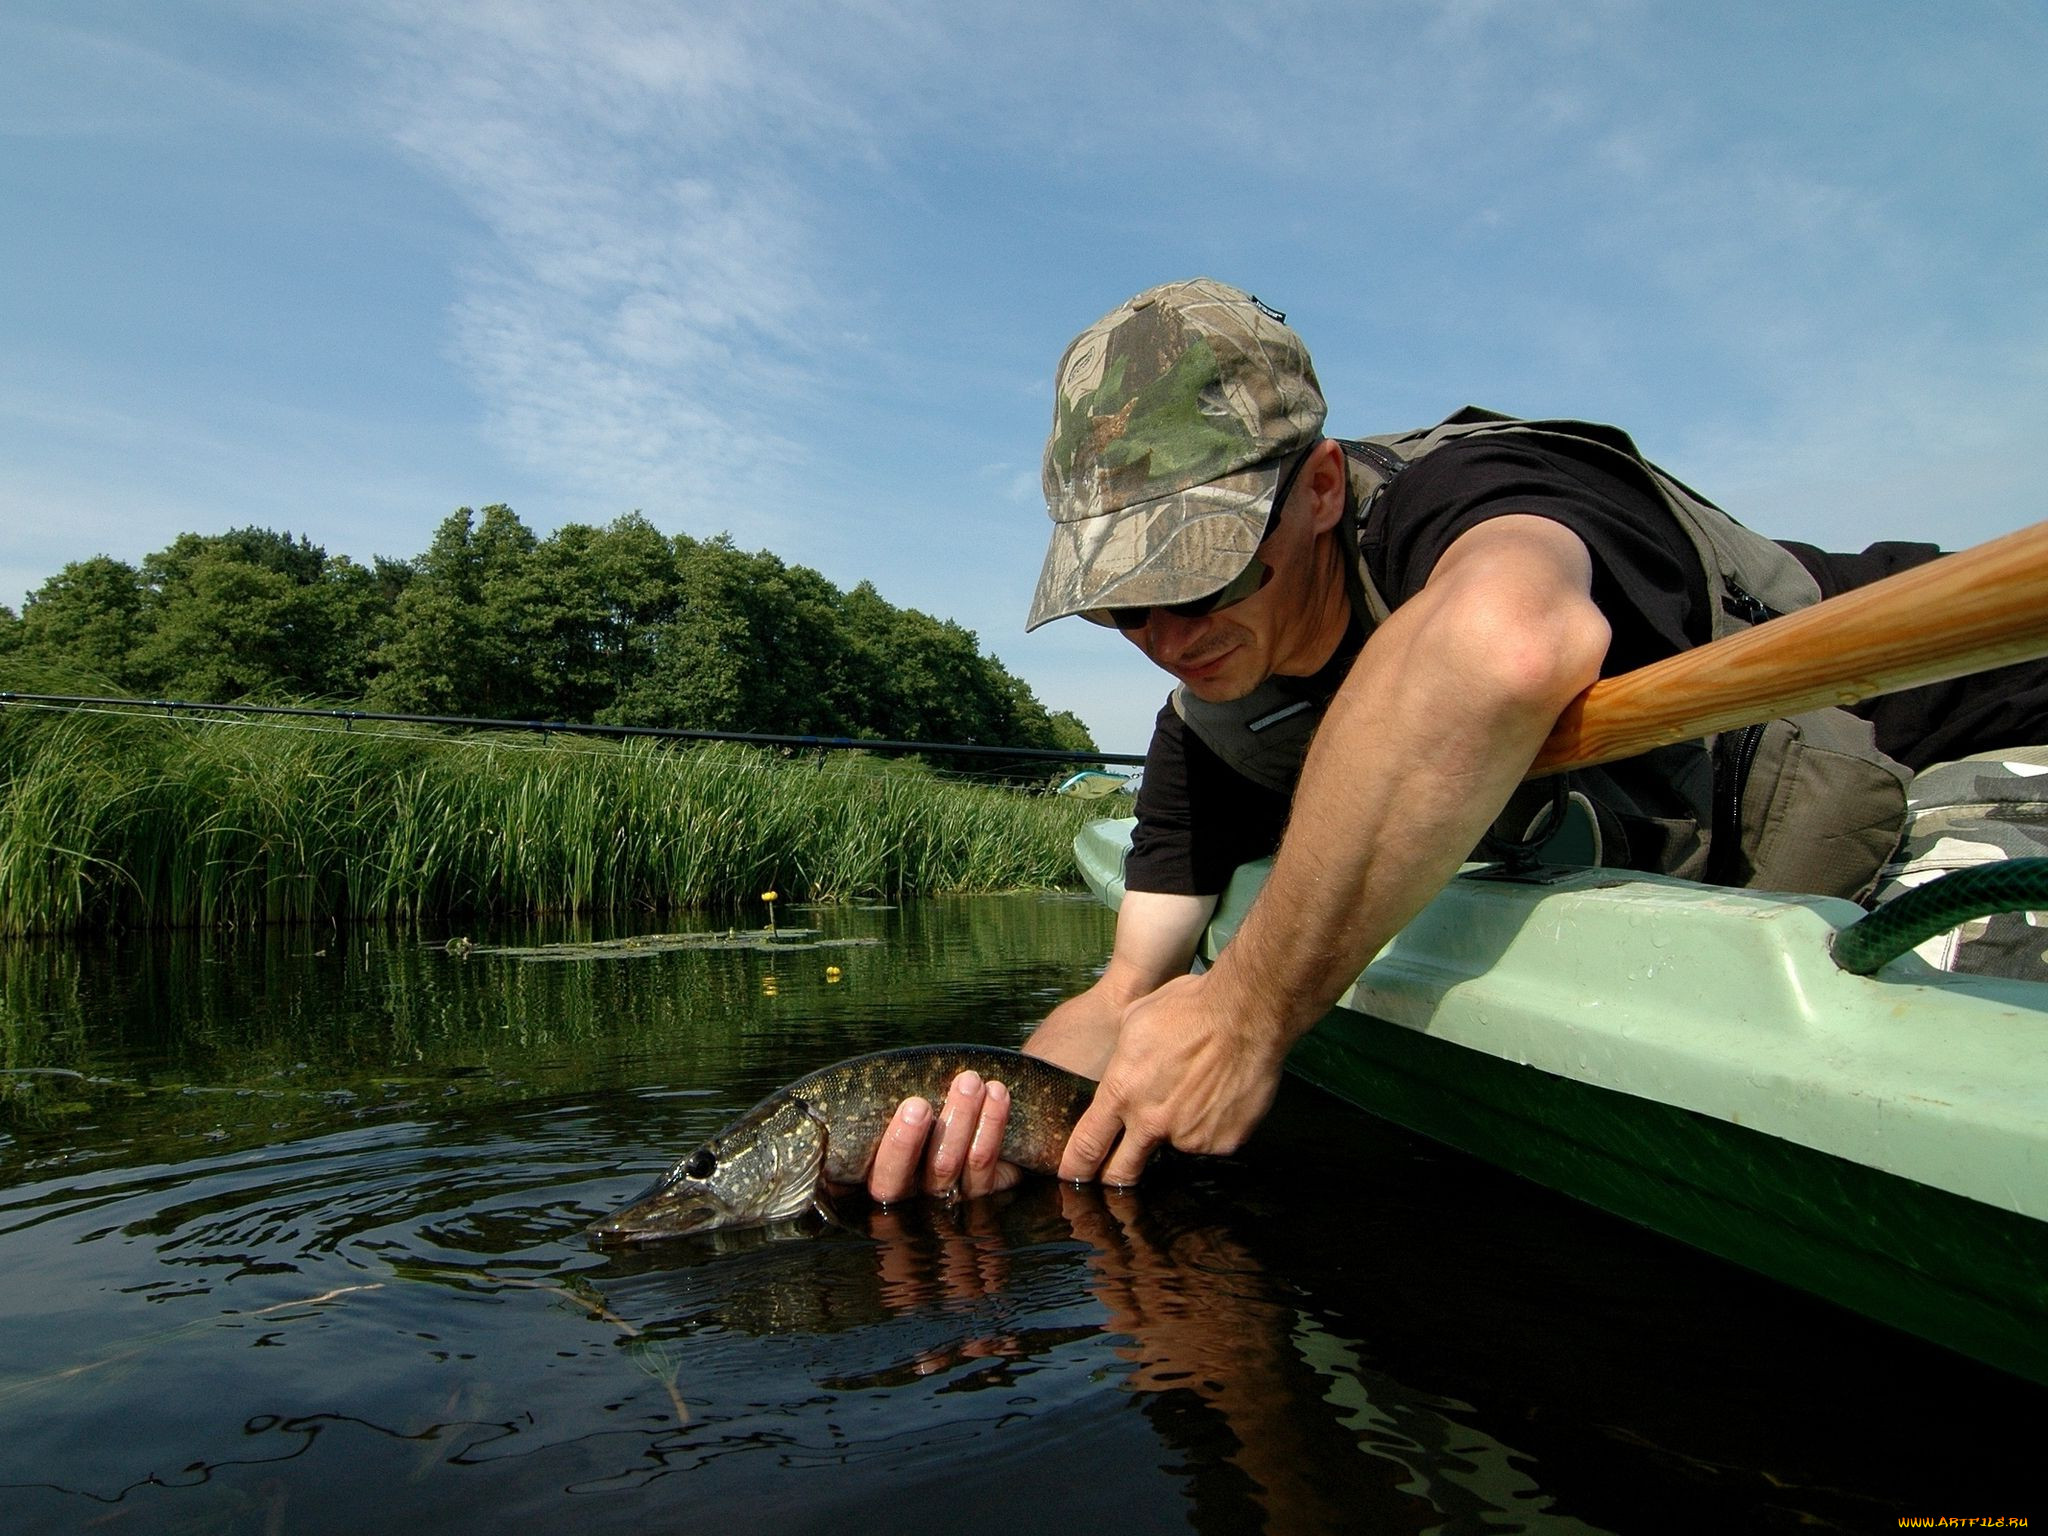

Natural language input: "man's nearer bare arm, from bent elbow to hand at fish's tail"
[1059,516,1608,1184]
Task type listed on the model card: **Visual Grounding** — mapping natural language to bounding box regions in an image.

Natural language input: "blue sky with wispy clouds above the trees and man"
[0,0,2048,752]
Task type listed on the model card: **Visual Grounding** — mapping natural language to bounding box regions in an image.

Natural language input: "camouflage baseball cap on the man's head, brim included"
[1024,276,1323,629]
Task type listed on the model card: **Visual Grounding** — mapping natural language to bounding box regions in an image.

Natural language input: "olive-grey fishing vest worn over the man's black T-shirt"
[1174,415,1911,899]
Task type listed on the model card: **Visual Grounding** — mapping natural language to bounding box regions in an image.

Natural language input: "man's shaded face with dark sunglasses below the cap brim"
[1124,442,1350,705]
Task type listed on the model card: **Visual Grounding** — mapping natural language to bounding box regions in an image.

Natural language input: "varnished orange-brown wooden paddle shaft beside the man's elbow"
[1530,522,2048,778]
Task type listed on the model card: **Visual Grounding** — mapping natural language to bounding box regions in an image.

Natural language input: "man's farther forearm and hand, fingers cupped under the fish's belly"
[868,891,1217,1200]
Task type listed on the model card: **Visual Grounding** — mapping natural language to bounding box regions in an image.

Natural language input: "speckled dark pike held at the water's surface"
[588,1044,1096,1245]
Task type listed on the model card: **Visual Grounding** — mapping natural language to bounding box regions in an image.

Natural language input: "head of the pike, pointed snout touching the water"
[586,1102,825,1247]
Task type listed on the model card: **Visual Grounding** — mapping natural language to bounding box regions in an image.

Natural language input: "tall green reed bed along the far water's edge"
[0,707,1102,934]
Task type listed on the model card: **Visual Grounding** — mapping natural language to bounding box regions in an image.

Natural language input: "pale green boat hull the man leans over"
[1075,819,2048,1384]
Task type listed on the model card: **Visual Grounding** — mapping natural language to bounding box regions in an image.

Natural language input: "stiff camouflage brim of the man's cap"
[1024,459,1288,631]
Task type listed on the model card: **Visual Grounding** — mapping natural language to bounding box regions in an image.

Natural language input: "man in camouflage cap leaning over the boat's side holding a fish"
[868,279,2048,1200]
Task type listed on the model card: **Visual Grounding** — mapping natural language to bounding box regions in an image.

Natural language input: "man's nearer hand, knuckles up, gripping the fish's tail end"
[1059,973,1286,1184]
